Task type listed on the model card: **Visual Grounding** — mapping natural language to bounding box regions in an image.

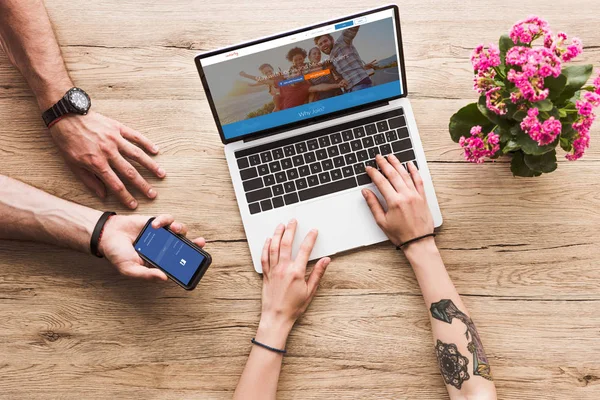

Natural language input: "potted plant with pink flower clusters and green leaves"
[449,17,600,176]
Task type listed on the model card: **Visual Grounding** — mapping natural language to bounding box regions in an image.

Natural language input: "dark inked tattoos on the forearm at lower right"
[430,299,492,382]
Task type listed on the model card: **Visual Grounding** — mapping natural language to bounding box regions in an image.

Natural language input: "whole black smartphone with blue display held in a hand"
[133,218,212,290]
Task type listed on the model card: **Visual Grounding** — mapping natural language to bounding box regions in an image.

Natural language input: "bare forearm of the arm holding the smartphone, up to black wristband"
[0,175,101,252]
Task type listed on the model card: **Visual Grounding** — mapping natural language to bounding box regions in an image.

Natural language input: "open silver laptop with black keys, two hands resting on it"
[195,5,442,273]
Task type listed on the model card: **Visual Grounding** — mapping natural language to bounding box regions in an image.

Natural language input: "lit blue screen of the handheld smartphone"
[135,224,206,286]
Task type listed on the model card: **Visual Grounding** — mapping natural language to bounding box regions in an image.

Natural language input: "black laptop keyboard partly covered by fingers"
[235,108,419,214]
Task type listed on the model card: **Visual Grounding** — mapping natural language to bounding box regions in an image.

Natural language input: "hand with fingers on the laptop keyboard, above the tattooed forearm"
[362,154,434,246]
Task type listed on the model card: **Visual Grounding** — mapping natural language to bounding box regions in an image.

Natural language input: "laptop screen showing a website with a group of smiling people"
[197,7,404,142]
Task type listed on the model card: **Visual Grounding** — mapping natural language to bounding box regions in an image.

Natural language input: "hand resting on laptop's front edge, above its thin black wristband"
[256,220,331,348]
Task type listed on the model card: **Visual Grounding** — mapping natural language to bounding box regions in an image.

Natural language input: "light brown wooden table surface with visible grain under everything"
[0,0,600,399]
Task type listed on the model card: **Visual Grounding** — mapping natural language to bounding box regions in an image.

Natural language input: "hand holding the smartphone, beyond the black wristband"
[98,215,206,281]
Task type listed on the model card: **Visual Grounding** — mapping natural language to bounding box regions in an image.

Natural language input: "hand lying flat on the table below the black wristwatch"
[50,111,166,209]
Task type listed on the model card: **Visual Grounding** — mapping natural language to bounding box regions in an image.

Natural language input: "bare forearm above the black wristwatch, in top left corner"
[0,0,73,111]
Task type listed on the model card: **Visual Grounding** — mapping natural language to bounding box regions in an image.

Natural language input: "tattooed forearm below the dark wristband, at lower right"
[405,238,496,399]
